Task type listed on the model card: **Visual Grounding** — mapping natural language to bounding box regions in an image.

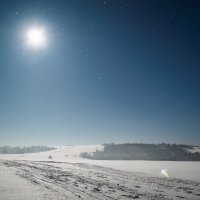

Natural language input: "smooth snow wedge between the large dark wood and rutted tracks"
[82,160,200,181]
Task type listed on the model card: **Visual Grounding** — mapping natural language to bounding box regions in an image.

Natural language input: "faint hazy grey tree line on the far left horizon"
[0,146,56,154]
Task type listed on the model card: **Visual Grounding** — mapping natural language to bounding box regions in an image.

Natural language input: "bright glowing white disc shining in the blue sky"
[27,27,47,48]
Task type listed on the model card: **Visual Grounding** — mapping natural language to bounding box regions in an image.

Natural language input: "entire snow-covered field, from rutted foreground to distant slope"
[0,145,200,200]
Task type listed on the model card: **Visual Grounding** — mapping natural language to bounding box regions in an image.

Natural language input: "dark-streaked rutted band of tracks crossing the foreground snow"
[0,161,200,200]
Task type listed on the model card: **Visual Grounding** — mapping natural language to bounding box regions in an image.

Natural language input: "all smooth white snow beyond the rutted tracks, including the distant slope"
[0,145,200,181]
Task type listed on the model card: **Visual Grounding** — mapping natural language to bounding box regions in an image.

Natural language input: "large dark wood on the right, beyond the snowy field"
[80,143,200,161]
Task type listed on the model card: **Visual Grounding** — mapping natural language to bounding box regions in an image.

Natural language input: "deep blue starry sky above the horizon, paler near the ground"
[0,0,200,145]
